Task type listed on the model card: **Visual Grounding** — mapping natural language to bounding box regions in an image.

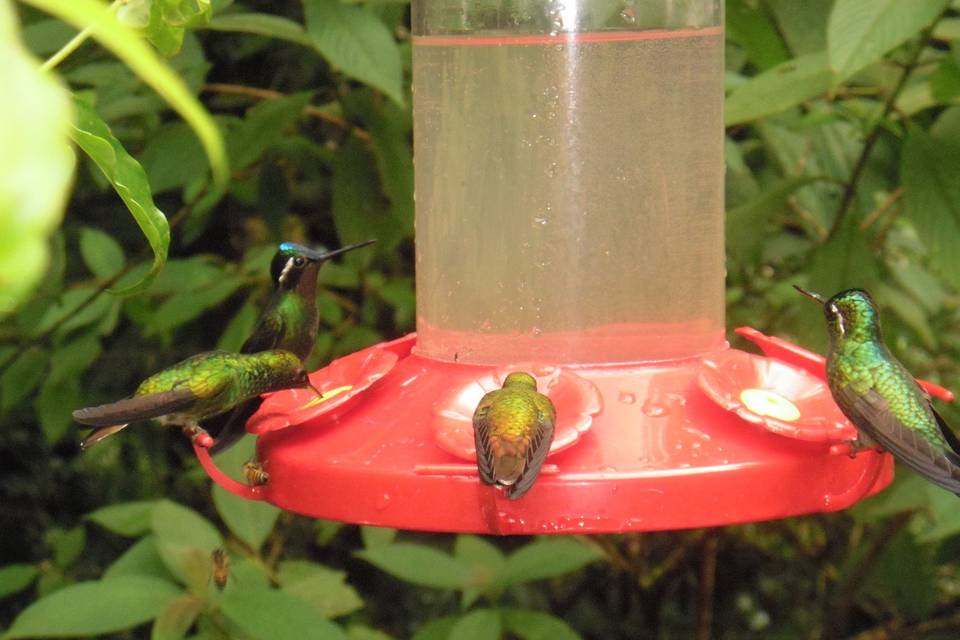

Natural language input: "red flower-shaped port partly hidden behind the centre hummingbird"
[433,365,603,461]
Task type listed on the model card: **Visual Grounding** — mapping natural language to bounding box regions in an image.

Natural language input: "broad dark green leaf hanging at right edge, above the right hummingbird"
[900,127,960,287]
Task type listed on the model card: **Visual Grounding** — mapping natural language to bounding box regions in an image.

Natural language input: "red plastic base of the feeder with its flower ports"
[195,328,952,534]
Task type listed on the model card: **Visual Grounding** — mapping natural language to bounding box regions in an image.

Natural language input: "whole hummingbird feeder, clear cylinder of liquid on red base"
[196,0,950,534]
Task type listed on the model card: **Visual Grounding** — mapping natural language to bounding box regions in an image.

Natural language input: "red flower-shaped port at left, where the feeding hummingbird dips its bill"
[247,347,399,435]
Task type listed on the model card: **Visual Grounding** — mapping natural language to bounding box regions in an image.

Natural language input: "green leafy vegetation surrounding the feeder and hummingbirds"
[0,0,960,640]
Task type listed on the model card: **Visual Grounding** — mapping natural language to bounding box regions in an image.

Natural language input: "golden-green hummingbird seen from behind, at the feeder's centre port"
[473,371,557,500]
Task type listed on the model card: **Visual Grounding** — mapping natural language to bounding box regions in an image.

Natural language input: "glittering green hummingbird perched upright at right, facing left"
[795,285,960,495]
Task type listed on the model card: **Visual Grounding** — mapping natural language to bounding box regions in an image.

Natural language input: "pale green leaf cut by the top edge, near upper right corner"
[827,0,949,84]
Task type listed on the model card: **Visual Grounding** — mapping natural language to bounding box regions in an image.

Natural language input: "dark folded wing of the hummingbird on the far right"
[837,385,960,495]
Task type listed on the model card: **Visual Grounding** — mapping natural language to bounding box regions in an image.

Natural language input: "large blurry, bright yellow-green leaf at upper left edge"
[0,2,75,318]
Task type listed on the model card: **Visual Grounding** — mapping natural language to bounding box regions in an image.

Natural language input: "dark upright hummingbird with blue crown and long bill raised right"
[207,240,376,453]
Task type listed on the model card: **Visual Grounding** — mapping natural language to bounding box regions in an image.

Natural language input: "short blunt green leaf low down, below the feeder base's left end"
[278,560,363,618]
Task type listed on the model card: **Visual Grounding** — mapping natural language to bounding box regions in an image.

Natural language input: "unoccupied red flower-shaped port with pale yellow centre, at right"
[698,349,857,443]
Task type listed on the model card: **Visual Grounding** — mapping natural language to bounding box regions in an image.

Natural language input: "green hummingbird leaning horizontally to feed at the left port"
[73,349,320,448]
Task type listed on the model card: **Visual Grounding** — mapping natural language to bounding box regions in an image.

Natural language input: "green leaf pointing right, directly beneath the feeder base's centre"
[500,538,600,587]
